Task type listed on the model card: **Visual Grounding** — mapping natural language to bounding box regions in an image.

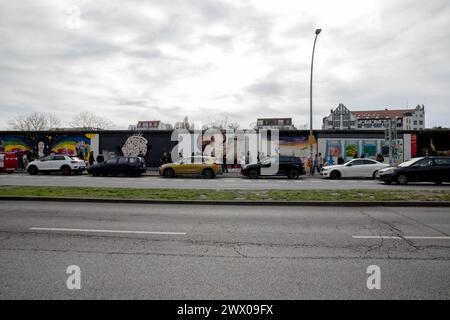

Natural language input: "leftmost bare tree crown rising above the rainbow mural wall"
[8,112,61,131]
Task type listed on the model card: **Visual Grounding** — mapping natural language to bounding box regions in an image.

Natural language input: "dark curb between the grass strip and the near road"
[0,196,450,207]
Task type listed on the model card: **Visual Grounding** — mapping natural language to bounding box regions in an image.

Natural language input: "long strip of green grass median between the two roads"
[0,186,450,202]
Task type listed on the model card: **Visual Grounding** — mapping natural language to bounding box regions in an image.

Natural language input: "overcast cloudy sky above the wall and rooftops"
[0,0,450,129]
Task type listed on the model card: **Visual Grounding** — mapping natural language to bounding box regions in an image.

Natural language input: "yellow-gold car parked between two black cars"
[159,156,222,179]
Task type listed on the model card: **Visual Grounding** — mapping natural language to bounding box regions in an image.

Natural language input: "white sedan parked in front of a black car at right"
[320,159,389,179]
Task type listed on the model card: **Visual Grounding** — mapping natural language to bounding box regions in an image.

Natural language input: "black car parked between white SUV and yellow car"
[88,157,146,177]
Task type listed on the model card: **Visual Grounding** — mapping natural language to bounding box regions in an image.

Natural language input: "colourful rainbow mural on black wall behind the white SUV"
[0,133,94,160]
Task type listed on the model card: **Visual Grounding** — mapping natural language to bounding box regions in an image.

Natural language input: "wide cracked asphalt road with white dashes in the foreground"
[0,201,450,299]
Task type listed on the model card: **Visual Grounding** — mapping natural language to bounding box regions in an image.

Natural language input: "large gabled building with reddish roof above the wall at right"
[322,103,425,130]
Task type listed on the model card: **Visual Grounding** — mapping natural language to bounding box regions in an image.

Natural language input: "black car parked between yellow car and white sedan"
[241,156,306,179]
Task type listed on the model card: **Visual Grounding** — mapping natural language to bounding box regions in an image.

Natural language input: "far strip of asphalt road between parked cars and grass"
[0,174,450,190]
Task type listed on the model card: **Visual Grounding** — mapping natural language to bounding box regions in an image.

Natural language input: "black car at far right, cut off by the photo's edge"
[376,157,450,184]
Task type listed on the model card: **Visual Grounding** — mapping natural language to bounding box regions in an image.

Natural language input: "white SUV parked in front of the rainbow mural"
[26,154,86,176]
